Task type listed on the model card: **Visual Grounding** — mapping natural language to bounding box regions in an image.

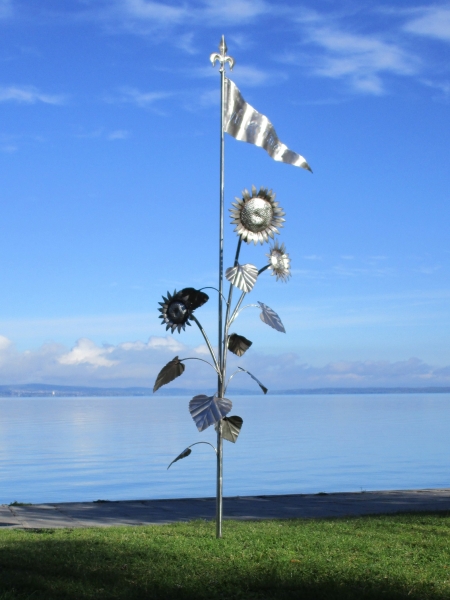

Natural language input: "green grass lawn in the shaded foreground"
[0,512,450,600]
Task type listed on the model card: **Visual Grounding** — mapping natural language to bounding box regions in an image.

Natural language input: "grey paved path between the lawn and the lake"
[0,489,450,529]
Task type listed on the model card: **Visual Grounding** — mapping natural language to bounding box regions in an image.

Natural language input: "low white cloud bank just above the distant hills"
[0,335,450,393]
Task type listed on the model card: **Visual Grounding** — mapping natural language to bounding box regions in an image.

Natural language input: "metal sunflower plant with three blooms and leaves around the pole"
[153,186,290,494]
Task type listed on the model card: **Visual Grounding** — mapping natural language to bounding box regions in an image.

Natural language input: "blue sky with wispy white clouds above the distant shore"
[0,0,450,393]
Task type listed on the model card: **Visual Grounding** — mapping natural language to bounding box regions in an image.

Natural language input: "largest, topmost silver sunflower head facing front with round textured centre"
[230,185,285,246]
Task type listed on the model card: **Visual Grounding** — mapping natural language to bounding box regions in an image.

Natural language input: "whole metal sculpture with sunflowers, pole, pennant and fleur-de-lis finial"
[153,36,311,538]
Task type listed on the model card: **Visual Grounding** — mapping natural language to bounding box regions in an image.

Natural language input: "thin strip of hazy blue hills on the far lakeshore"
[0,383,450,398]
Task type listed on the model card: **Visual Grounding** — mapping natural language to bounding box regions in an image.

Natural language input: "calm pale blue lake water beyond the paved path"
[0,394,450,503]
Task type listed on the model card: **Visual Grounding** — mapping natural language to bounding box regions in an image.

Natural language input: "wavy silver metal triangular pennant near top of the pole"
[224,77,312,173]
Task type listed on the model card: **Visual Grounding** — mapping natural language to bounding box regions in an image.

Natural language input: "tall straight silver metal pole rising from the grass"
[216,52,225,538]
